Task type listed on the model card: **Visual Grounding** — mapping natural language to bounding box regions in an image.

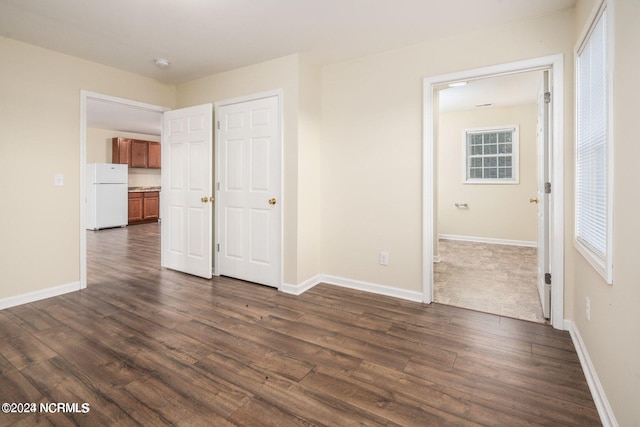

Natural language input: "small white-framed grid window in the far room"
[463,126,519,184]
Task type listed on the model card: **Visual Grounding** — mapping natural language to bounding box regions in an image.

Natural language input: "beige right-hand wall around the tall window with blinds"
[569,0,640,426]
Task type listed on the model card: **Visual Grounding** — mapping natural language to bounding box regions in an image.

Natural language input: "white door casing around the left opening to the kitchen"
[80,90,171,289]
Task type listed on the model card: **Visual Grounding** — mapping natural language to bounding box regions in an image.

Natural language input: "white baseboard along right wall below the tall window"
[564,319,618,427]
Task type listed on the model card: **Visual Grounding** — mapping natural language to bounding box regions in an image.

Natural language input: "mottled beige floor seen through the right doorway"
[434,240,545,323]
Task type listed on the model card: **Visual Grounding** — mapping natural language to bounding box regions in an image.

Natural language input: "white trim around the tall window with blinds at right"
[573,0,615,285]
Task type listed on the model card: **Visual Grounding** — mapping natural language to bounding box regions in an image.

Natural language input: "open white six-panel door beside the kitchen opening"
[160,104,213,279]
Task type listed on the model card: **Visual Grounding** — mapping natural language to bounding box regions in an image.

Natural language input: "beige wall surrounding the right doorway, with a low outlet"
[322,10,575,294]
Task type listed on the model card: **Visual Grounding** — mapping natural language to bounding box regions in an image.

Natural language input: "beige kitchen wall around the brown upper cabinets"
[87,128,161,187]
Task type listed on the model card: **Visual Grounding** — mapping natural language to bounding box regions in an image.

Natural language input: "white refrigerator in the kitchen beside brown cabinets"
[86,163,129,230]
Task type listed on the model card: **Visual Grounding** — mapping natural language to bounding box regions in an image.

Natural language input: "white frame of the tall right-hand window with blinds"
[573,0,614,285]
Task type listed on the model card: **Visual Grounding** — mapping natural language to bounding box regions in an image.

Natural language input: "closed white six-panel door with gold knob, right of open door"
[216,96,282,287]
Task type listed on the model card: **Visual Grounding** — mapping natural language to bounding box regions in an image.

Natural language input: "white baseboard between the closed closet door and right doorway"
[280,274,422,302]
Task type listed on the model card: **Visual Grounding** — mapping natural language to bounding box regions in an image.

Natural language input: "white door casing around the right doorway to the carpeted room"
[422,54,565,329]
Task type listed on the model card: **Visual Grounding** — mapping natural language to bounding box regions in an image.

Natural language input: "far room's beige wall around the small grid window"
[437,104,538,242]
